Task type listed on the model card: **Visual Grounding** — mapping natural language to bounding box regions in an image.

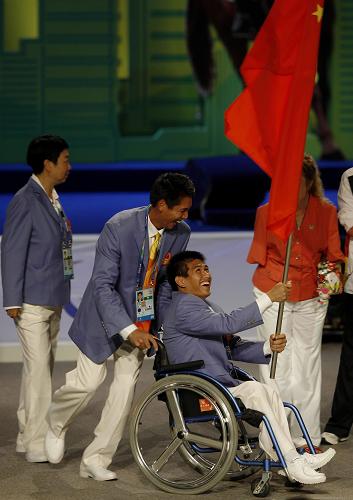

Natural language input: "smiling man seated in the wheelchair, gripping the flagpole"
[163,251,335,484]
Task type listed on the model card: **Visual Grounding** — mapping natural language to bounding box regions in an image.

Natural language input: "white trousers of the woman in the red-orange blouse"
[254,288,327,446]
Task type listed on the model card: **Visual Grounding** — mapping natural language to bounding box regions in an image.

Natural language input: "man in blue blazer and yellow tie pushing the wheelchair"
[46,173,194,481]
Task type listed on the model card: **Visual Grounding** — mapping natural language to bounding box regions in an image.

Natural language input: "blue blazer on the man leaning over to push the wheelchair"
[69,207,190,363]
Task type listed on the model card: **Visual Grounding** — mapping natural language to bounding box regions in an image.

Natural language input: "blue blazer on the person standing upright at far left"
[1,178,71,307]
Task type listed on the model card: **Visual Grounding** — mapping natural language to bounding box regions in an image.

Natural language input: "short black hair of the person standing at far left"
[27,135,69,175]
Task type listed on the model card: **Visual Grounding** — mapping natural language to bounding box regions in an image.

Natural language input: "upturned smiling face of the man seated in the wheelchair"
[176,259,212,299]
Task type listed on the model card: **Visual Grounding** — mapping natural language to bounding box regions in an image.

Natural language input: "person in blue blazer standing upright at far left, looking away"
[1,135,73,462]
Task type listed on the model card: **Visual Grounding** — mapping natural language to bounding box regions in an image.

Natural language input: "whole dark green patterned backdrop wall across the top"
[0,0,353,162]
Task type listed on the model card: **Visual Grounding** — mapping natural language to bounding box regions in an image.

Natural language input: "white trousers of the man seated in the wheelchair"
[229,381,297,460]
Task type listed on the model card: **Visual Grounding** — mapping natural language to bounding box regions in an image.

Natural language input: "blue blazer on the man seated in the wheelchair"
[163,292,271,386]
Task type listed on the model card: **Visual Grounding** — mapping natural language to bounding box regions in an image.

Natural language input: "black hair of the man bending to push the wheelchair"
[150,172,195,208]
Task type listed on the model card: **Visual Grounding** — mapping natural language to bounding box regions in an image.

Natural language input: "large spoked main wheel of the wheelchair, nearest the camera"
[130,374,238,494]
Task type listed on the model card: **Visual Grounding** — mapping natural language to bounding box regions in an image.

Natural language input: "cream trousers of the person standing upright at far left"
[15,304,62,454]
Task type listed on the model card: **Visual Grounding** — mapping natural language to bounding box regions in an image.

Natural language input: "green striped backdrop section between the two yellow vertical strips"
[41,0,117,161]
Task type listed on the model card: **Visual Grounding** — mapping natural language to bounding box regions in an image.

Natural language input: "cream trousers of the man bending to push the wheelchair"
[48,342,144,468]
